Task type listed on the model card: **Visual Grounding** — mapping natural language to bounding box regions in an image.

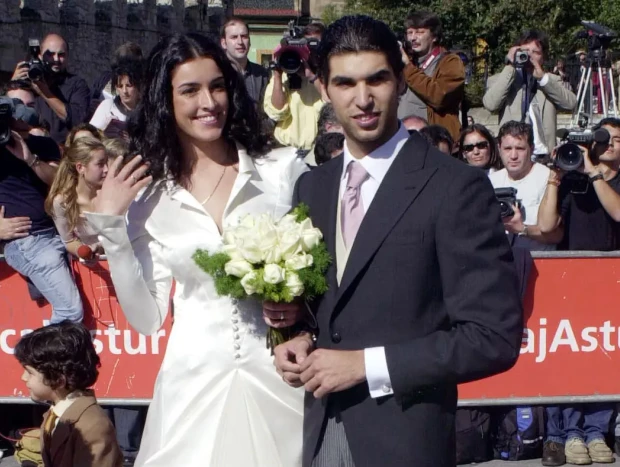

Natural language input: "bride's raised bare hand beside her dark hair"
[93,156,153,216]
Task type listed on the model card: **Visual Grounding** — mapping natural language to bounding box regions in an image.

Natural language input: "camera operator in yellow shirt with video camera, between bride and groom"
[263,23,325,157]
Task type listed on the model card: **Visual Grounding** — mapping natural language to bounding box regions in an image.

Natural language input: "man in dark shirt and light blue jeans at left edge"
[0,93,83,323]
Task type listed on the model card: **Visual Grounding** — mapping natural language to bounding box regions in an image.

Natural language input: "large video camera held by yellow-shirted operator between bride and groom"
[274,20,319,89]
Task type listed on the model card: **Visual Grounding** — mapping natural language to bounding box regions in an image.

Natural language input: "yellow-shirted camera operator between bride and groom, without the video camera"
[263,23,324,157]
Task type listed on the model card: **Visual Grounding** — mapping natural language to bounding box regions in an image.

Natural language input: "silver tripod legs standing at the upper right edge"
[571,49,618,127]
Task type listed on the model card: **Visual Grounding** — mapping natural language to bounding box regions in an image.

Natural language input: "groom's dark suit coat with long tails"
[294,134,523,467]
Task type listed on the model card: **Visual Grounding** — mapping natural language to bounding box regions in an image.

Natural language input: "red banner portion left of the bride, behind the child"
[0,260,170,400]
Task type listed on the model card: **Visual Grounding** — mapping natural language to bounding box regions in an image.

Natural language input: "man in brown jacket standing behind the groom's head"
[398,11,465,141]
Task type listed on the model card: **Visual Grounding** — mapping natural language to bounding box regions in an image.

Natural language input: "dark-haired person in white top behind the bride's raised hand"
[90,58,143,138]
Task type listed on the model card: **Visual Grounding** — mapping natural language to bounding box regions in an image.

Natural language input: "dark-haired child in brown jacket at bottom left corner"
[15,321,123,467]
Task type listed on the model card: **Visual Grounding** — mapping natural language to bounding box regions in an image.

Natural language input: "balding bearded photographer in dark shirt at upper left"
[12,34,90,144]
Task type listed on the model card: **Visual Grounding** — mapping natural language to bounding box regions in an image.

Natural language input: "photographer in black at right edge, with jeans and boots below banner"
[538,118,620,466]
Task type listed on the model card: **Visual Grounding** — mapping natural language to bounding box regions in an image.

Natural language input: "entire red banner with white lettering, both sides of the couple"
[0,257,620,404]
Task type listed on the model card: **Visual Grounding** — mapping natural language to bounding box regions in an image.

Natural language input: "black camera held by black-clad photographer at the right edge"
[553,128,610,172]
